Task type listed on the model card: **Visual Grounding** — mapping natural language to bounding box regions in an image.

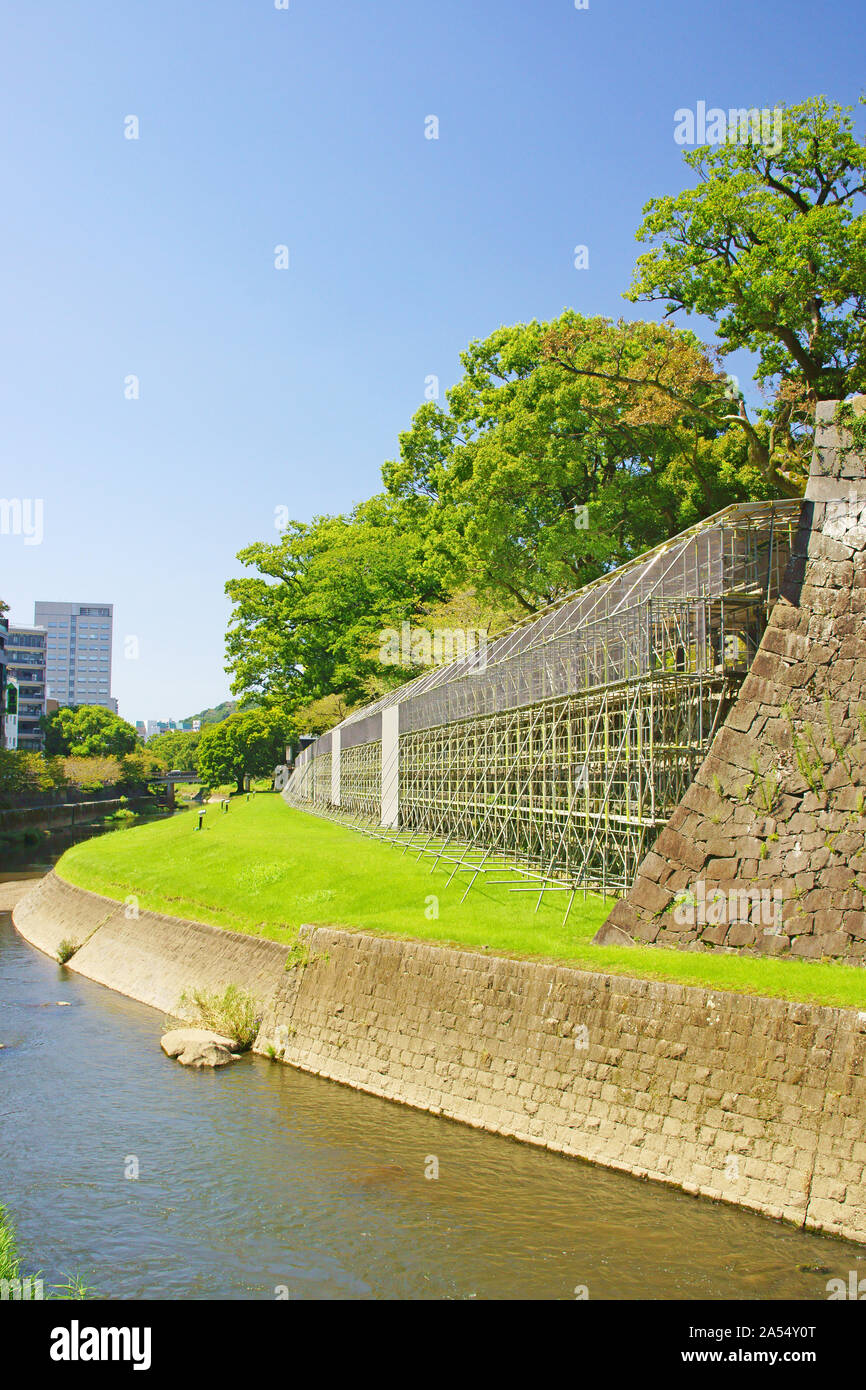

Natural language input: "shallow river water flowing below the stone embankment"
[0,867,866,1300]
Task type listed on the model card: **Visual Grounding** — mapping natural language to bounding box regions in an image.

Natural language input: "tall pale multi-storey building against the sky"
[35,603,117,713]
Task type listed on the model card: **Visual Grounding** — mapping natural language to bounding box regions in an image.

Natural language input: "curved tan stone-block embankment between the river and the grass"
[14,874,866,1241]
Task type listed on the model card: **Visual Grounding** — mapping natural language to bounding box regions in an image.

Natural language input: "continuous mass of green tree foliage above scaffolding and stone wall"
[227,96,866,733]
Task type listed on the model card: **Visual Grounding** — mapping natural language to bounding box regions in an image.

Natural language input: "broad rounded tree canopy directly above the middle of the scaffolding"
[384,311,778,612]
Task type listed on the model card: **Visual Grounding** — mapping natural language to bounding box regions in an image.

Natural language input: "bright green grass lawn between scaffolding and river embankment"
[57,792,866,1008]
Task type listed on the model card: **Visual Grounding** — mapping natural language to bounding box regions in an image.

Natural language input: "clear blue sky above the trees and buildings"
[0,0,863,719]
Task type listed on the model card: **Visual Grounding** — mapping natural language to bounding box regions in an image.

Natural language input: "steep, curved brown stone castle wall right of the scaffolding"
[595,396,866,963]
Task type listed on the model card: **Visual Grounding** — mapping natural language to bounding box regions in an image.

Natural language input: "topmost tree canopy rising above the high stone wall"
[628,97,866,400]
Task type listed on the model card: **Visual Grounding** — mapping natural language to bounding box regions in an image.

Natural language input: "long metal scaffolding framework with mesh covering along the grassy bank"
[286,502,799,908]
